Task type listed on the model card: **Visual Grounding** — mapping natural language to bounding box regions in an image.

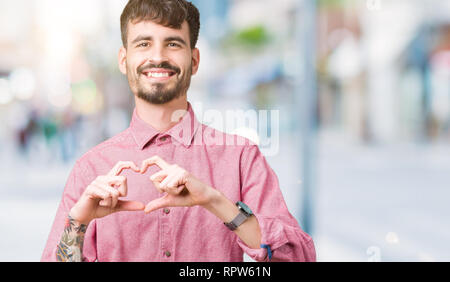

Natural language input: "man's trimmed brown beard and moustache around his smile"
[127,62,192,105]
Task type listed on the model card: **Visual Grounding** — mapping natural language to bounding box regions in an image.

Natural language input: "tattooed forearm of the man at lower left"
[56,216,87,262]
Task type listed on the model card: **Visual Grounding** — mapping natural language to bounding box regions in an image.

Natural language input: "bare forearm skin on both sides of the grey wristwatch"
[204,190,261,249]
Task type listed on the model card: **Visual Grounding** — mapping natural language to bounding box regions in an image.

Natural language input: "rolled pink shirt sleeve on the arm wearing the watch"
[237,145,316,262]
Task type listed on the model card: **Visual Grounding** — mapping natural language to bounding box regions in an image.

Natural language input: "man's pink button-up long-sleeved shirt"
[41,104,316,262]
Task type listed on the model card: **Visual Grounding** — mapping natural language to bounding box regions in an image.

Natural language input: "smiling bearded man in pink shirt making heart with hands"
[42,0,316,262]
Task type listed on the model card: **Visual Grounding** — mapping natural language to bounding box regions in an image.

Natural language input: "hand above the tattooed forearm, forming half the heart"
[69,161,144,225]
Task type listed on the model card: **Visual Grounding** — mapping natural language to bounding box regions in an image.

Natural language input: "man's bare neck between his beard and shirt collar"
[135,95,188,132]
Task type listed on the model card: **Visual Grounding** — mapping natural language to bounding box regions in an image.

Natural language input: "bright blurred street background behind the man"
[0,0,450,261]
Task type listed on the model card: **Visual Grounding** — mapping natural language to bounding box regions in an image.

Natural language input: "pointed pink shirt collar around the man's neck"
[130,102,199,150]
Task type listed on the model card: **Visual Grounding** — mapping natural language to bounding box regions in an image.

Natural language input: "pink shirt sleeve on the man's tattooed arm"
[41,161,97,262]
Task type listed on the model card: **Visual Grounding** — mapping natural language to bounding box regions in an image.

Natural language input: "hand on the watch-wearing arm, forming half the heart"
[141,156,217,213]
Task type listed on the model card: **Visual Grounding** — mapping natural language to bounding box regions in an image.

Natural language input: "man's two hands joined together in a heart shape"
[70,156,199,224]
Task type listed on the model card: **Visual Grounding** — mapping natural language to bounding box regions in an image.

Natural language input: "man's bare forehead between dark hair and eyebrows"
[128,21,189,42]
